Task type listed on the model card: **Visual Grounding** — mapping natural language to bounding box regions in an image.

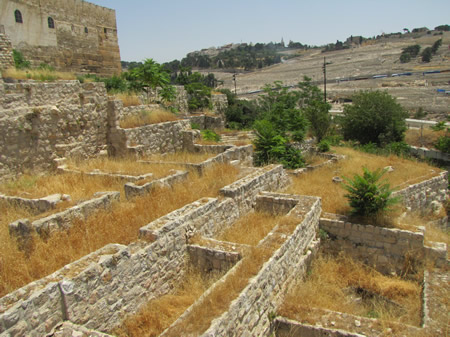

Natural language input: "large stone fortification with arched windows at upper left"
[0,0,121,75]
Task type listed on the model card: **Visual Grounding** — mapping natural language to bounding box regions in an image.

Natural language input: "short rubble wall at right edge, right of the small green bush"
[392,171,448,211]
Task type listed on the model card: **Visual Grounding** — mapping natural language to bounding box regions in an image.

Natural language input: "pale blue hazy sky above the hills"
[89,0,450,63]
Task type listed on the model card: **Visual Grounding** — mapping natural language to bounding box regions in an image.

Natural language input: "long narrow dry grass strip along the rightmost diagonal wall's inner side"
[163,217,299,337]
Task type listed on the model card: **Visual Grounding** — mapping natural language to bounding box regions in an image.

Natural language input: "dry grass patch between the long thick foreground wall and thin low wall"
[113,269,222,337]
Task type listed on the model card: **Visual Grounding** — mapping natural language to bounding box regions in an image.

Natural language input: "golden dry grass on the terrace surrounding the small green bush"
[286,147,441,214]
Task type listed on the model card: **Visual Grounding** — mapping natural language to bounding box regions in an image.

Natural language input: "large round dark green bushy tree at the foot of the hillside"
[341,90,408,146]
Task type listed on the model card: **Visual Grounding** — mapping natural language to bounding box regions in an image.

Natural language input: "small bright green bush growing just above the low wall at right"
[343,167,399,216]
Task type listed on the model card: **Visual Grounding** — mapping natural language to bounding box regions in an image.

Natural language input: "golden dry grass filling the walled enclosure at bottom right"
[279,255,421,326]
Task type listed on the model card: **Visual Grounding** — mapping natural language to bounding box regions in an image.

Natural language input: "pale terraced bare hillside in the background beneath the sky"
[204,32,450,120]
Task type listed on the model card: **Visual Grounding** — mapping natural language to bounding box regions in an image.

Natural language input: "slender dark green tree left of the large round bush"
[298,76,331,143]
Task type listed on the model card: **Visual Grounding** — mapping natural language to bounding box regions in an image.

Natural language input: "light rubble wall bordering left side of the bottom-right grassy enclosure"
[202,197,321,337]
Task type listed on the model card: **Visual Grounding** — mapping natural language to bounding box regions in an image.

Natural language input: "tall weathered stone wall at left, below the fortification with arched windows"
[0,81,107,178]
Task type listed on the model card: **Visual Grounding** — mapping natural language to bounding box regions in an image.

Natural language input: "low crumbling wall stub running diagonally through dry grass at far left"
[9,192,120,240]
